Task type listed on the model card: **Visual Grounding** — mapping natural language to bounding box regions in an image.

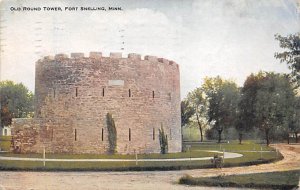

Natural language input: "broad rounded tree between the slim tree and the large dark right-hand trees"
[203,76,239,143]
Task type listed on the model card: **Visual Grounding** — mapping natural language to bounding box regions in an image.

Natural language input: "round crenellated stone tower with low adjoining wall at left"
[12,52,182,154]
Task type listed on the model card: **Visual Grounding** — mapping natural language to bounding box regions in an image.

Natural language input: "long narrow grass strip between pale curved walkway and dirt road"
[0,161,216,171]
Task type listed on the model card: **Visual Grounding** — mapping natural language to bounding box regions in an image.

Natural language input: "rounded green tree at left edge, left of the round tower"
[0,81,33,125]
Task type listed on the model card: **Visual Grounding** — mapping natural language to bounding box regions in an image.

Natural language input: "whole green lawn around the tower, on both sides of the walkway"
[0,138,281,171]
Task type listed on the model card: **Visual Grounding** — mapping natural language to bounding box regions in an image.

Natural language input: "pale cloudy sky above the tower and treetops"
[0,0,300,98]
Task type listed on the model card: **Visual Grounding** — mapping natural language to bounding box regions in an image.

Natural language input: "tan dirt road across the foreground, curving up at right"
[0,144,300,190]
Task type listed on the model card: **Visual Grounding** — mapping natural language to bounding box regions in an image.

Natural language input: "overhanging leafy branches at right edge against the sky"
[274,33,300,86]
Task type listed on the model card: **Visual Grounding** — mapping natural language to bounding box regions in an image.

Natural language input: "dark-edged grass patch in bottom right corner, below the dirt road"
[179,170,300,189]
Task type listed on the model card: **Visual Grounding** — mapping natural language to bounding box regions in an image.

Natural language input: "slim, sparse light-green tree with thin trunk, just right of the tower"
[187,88,207,142]
